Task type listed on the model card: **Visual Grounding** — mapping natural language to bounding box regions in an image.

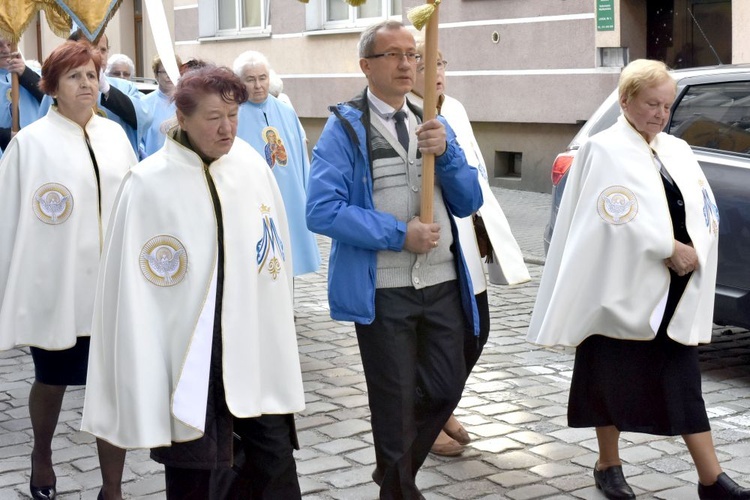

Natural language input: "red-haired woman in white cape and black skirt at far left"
[0,42,136,500]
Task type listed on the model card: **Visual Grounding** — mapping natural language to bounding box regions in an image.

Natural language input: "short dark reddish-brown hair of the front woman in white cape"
[172,65,248,116]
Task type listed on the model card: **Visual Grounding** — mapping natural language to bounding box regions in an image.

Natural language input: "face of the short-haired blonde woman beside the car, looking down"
[620,80,675,142]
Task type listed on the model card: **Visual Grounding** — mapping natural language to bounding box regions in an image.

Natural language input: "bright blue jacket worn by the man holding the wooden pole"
[307,90,482,334]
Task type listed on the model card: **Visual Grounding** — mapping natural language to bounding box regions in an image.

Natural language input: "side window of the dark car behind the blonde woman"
[669,81,750,153]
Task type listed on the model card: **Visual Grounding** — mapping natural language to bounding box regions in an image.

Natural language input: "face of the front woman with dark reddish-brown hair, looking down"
[177,93,239,160]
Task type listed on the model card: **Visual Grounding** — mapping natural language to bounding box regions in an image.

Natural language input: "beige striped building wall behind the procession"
[16,0,750,191]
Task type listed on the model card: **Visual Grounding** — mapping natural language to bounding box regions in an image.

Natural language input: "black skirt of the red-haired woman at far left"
[30,337,91,385]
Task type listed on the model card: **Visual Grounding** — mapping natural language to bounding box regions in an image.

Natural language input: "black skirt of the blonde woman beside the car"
[568,271,711,436]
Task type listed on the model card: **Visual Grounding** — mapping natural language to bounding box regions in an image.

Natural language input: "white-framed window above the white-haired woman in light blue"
[198,0,270,37]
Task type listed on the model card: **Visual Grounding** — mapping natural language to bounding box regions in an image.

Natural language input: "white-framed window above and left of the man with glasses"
[307,0,401,29]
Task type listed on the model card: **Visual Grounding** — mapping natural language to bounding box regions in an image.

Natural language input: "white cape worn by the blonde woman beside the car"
[527,116,718,346]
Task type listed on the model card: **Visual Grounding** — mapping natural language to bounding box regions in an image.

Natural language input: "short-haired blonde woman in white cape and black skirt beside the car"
[528,59,750,499]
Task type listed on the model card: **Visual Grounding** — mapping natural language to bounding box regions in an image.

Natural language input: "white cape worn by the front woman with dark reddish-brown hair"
[82,137,304,448]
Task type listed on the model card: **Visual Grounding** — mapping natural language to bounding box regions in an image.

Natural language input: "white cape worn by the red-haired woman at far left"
[0,107,136,350]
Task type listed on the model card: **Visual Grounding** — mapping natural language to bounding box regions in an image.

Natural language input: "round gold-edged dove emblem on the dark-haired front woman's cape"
[139,235,187,286]
